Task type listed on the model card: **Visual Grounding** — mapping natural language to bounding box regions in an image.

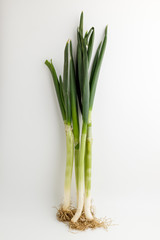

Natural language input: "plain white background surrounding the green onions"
[0,0,160,240]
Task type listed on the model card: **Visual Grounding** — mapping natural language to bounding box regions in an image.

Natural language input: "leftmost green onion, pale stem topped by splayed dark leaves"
[45,42,74,210]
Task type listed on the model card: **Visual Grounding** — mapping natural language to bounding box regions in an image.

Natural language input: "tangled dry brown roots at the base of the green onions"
[57,207,112,231]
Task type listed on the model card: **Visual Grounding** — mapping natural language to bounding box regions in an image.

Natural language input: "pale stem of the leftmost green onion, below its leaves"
[63,124,74,210]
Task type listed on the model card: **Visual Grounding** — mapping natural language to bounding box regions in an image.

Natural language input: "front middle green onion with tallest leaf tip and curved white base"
[71,13,89,222]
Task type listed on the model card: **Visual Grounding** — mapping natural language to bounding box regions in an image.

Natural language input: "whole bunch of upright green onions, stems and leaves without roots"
[45,12,107,223]
